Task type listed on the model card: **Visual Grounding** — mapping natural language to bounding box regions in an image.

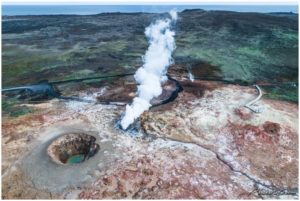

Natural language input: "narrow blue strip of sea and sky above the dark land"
[2,4,298,16]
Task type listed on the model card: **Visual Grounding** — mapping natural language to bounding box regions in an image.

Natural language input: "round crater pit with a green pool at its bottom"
[47,134,100,165]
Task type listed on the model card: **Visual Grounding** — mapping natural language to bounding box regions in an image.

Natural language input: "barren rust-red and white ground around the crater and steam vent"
[2,72,298,199]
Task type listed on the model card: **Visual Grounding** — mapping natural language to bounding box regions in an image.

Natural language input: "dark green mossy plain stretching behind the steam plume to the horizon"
[2,11,298,89]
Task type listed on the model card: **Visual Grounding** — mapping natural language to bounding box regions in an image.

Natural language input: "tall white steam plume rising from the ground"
[121,10,177,129]
